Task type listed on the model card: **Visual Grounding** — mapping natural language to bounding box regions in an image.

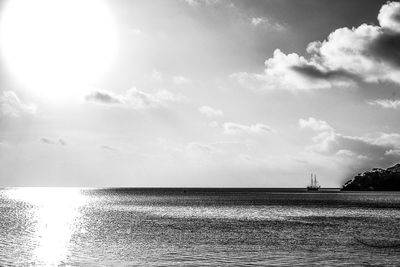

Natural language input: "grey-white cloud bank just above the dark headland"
[299,118,400,172]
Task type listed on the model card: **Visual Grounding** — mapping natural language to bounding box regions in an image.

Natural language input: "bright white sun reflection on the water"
[9,188,84,265]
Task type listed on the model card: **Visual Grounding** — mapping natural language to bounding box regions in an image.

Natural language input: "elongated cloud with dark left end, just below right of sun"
[85,88,184,109]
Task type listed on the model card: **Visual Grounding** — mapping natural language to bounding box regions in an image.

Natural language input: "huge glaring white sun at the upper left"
[0,0,117,100]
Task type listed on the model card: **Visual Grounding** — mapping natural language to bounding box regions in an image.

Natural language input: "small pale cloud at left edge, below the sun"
[0,91,36,118]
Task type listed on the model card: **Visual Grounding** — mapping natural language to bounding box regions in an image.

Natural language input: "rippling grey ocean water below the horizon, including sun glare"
[0,188,400,266]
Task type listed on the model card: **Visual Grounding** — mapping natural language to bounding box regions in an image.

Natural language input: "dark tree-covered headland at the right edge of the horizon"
[342,163,400,191]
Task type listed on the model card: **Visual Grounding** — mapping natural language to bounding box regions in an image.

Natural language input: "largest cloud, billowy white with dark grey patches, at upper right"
[231,2,400,91]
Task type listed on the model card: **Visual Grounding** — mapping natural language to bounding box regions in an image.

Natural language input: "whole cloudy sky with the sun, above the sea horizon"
[0,0,400,187]
